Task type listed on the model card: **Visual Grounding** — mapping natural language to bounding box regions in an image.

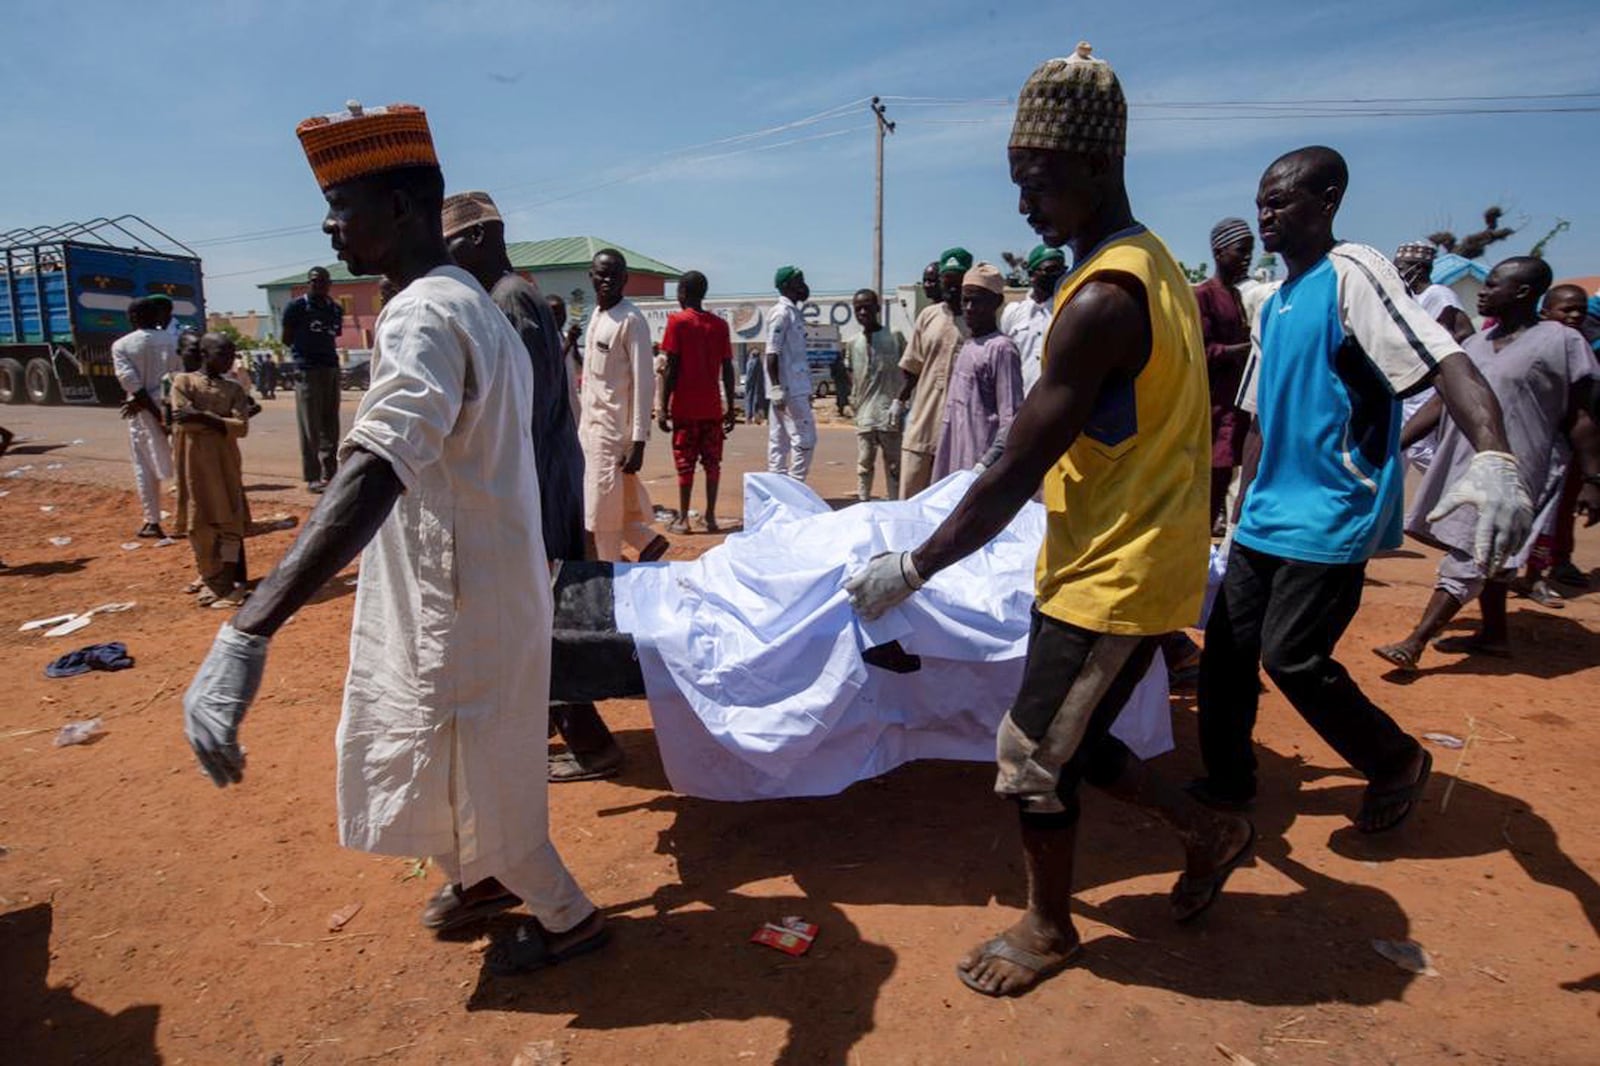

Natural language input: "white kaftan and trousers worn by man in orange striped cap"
[338,266,594,930]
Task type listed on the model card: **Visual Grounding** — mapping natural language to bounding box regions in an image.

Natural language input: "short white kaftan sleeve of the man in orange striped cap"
[339,301,467,491]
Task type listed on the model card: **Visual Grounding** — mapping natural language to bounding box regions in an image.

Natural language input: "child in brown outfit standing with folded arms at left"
[173,333,250,608]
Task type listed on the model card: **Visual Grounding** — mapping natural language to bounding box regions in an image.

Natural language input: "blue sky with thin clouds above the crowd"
[0,0,1600,311]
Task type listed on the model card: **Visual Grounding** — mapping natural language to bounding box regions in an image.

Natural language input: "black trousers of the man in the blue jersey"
[1200,544,1418,800]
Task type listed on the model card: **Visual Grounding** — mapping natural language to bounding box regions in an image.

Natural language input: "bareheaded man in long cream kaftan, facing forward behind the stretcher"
[578,248,667,562]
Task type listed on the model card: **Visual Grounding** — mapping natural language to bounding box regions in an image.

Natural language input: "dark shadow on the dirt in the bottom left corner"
[0,903,162,1066]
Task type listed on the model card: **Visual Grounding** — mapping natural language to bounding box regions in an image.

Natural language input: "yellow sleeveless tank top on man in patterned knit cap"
[1035,227,1211,635]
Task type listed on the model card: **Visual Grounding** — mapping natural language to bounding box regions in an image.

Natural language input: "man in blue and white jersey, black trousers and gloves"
[1192,147,1533,832]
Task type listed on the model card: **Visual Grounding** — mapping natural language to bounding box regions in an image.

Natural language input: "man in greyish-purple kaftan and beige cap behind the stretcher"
[933,262,1022,480]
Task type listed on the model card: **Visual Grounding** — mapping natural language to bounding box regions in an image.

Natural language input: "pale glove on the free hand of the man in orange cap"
[184,623,267,789]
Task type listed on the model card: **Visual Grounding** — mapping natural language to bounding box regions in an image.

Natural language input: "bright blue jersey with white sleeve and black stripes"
[1234,243,1461,563]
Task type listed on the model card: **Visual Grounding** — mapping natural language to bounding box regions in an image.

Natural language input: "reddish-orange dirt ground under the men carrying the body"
[0,425,1600,1066]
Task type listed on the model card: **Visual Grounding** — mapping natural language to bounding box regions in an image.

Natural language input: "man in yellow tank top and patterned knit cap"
[846,45,1254,996]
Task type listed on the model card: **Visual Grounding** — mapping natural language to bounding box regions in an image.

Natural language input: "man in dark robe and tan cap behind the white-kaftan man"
[444,192,622,781]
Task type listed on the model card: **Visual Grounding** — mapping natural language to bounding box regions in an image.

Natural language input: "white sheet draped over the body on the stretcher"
[614,471,1173,800]
